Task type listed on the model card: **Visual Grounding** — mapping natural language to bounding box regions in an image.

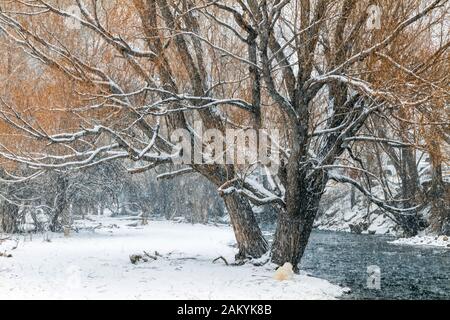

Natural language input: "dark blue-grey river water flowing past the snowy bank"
[301,231,450,299]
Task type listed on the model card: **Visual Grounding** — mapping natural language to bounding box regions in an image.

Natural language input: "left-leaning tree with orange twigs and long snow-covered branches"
[0,1,267,258]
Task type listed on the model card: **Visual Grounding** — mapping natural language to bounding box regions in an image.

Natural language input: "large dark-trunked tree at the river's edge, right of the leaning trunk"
[209,1,448,265]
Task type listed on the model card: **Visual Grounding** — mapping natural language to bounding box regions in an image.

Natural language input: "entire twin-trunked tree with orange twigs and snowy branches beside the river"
[0,0,448,265]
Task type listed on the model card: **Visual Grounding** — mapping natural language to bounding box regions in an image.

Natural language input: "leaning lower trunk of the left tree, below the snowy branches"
[224,194,268,260]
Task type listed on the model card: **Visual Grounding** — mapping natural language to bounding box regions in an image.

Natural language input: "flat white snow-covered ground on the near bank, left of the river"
[0,217,343,300]
